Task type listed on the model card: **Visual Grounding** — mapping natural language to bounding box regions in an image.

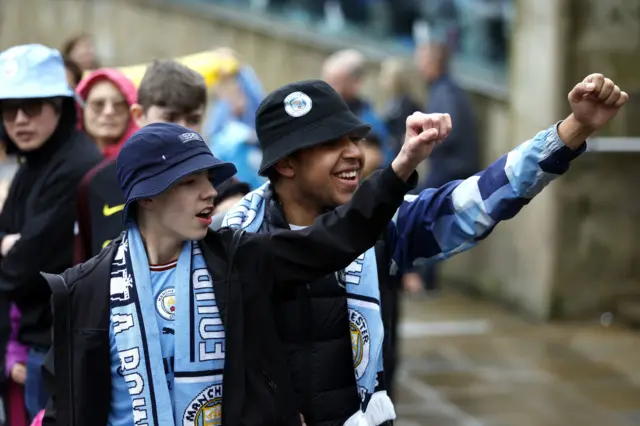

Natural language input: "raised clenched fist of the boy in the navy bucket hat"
[391,112,451,180]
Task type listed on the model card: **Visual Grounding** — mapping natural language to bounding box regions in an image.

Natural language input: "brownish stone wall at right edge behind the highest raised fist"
[552,0,640,317]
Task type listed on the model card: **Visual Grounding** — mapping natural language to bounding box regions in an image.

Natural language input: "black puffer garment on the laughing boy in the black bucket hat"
[259,192,398,426]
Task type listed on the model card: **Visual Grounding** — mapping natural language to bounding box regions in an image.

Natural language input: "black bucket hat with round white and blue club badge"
[256,80,371,176]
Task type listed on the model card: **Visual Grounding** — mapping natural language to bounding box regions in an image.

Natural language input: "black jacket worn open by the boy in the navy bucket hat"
[44,169,417,426]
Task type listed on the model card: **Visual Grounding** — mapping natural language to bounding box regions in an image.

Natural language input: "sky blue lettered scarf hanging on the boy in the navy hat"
[110,227,224,426]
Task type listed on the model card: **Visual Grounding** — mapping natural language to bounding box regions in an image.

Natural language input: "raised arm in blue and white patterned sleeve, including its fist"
[390,75,627,271]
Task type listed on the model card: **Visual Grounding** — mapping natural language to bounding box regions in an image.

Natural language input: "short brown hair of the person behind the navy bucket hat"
[138,59,207,114]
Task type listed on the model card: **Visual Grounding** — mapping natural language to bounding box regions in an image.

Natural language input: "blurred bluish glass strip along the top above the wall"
[190,0,514,66]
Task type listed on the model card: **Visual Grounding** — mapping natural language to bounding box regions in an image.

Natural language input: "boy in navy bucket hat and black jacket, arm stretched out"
[43,114,444,426]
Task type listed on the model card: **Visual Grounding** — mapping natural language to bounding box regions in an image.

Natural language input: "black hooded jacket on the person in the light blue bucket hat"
[0,98,102,349]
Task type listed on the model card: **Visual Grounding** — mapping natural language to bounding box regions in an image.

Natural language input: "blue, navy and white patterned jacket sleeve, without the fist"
[389,121,586,272]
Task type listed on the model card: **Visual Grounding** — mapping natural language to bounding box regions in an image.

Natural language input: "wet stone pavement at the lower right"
[395,294,640,426]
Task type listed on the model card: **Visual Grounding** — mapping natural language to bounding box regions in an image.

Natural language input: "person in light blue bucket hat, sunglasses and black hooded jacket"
[0,44,102,418]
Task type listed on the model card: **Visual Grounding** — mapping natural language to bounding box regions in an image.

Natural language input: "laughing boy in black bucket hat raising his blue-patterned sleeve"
[220,74,628,426]
